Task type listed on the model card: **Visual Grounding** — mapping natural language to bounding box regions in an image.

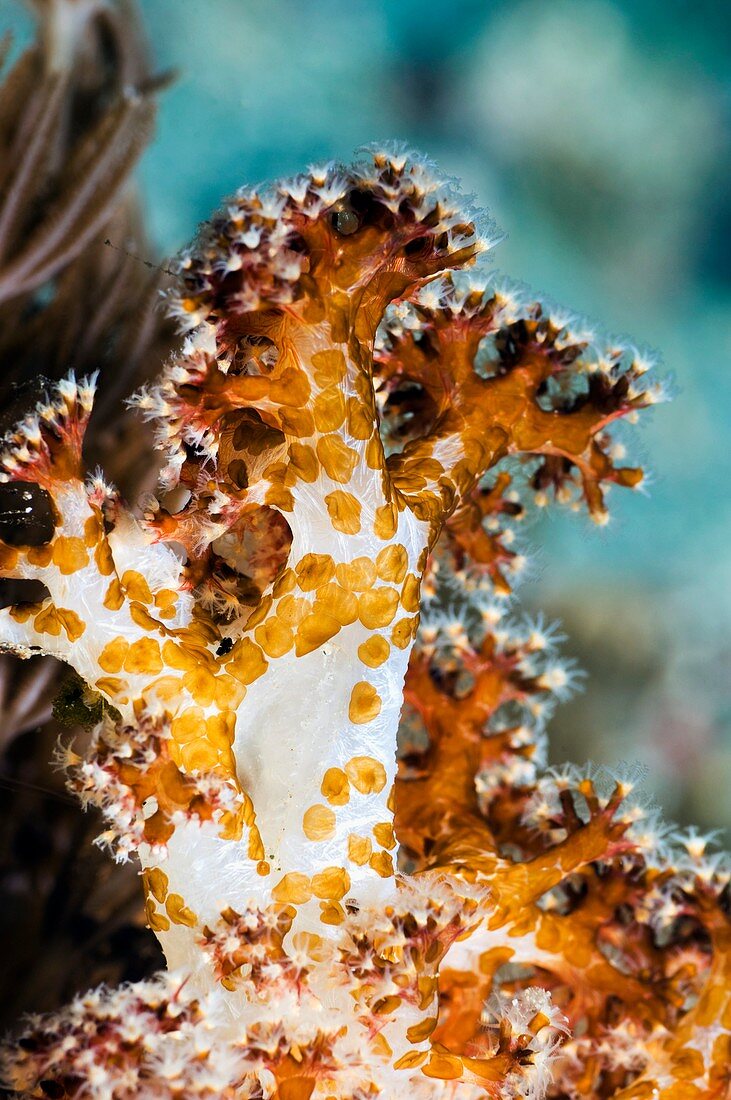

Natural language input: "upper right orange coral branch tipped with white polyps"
[376,277,662,530]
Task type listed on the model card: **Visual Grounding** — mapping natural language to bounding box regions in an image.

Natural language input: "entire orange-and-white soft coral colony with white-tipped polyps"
[0,150,731,1100]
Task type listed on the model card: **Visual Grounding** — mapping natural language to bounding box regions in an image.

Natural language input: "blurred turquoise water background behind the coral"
[0,0,731,1008]
